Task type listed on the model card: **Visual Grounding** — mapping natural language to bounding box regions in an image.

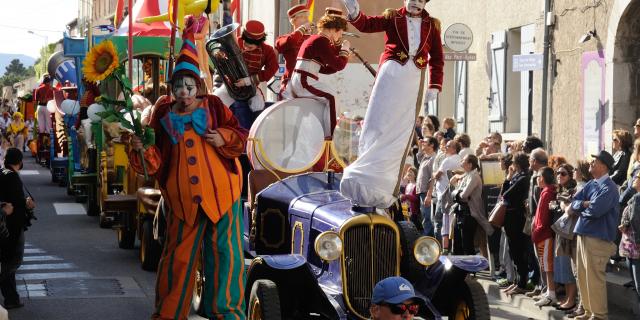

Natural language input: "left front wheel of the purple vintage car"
[247,280,282,320]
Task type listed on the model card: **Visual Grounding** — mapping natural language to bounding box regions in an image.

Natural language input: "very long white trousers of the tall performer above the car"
[340,60,423,208]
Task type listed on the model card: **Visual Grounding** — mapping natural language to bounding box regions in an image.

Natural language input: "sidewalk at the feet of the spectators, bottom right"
[476,266,640,320]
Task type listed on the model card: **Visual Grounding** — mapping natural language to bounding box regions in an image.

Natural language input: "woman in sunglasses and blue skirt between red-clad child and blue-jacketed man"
[551,164,577,311]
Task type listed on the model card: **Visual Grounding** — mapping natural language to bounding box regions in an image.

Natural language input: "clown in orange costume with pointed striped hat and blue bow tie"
[129,25,248,320]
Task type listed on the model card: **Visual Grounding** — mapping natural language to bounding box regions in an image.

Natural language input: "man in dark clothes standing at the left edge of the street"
[0,148,35,309]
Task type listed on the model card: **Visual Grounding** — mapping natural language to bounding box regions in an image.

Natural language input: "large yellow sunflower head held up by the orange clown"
[82,40,118,82]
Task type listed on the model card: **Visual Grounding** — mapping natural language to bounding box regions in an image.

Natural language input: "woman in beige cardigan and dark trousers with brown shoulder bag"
[451,154,493,255]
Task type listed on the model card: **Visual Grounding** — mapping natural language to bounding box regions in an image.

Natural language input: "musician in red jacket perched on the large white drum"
[289,8,351,140]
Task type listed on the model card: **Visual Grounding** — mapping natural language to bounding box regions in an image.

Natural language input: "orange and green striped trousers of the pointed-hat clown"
[152,200,245,320]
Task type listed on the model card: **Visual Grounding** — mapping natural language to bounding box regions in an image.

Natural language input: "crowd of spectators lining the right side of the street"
[401,115,640,319]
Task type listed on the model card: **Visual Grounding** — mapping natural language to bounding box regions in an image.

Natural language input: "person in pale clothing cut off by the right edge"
[618,177,640,310]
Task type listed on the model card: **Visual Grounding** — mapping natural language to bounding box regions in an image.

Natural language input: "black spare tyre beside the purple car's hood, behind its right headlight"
[398,221,425,283]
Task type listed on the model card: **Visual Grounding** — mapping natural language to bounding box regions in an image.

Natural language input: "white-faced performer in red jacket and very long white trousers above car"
[340,0,444,208]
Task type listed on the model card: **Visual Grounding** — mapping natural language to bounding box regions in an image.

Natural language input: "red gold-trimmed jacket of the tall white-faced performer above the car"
[350,7,444,90]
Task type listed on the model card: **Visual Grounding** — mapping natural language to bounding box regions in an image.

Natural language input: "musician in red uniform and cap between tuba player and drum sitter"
[275,4,312,99]
